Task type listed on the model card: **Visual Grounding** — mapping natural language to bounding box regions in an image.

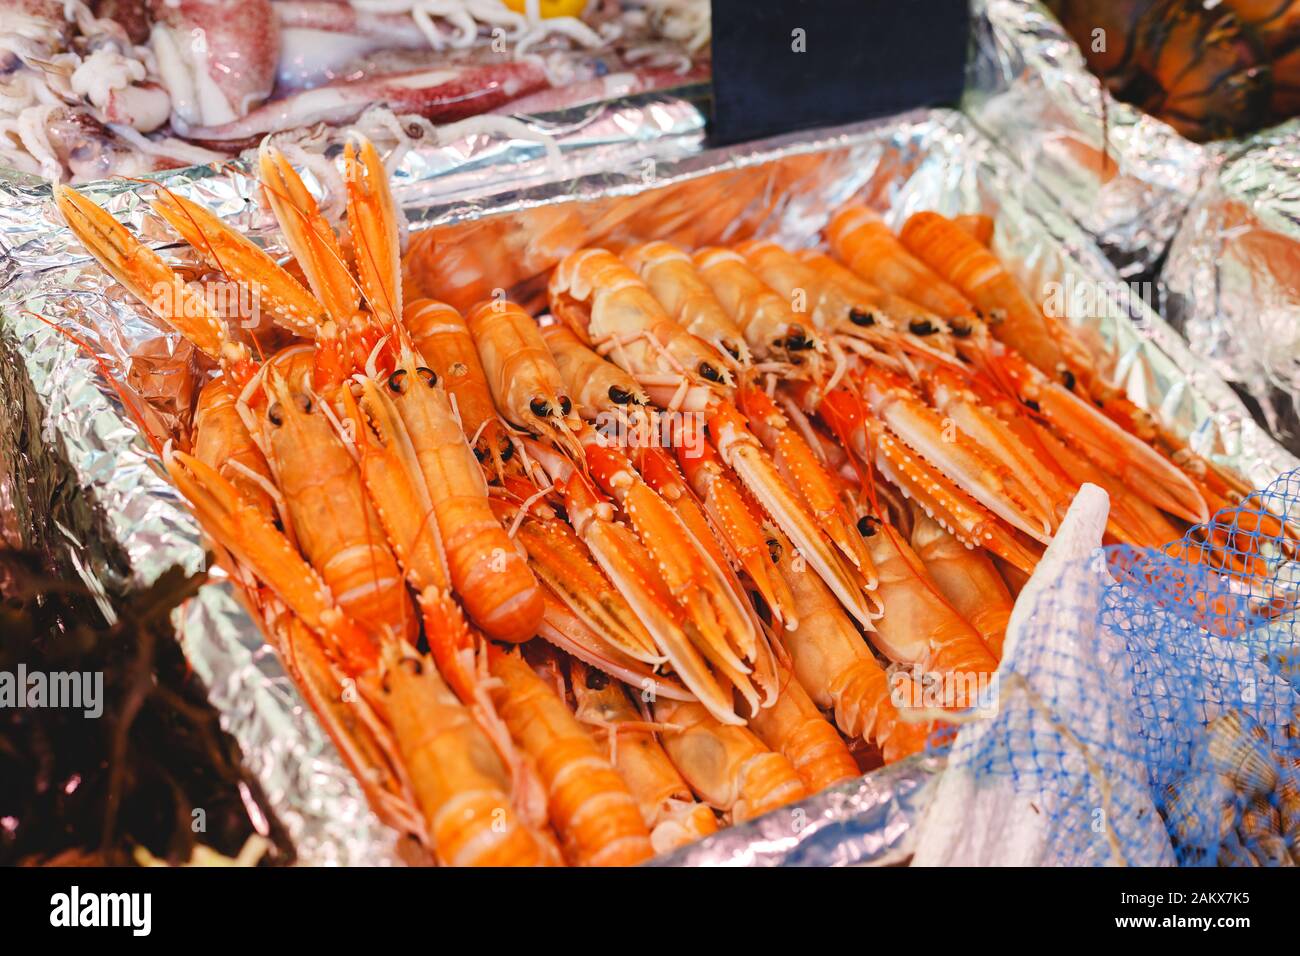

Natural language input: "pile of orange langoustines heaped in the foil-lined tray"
[56,139,1258,865]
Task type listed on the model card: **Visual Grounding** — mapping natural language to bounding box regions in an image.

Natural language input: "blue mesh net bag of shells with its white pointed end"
[918,472,1300,866]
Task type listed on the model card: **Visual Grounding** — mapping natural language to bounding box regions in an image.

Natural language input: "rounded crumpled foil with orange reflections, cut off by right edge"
[1160,121,1300,453]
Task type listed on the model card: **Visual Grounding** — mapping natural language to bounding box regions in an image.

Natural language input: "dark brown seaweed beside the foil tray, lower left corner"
[0,551,293,865]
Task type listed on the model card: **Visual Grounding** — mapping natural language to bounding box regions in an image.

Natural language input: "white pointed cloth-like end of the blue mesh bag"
[913,484,1174,866]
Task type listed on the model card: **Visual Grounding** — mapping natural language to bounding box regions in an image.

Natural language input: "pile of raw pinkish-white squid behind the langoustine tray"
[0,0,709,182]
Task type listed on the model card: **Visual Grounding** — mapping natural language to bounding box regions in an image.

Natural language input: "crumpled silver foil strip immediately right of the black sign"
[963,0,1216,280]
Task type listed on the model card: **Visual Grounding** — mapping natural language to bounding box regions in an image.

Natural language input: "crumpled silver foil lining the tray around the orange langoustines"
[0,89,1300,865]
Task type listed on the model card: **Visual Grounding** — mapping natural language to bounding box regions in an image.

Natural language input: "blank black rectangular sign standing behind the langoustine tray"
[711,0,970,144]
